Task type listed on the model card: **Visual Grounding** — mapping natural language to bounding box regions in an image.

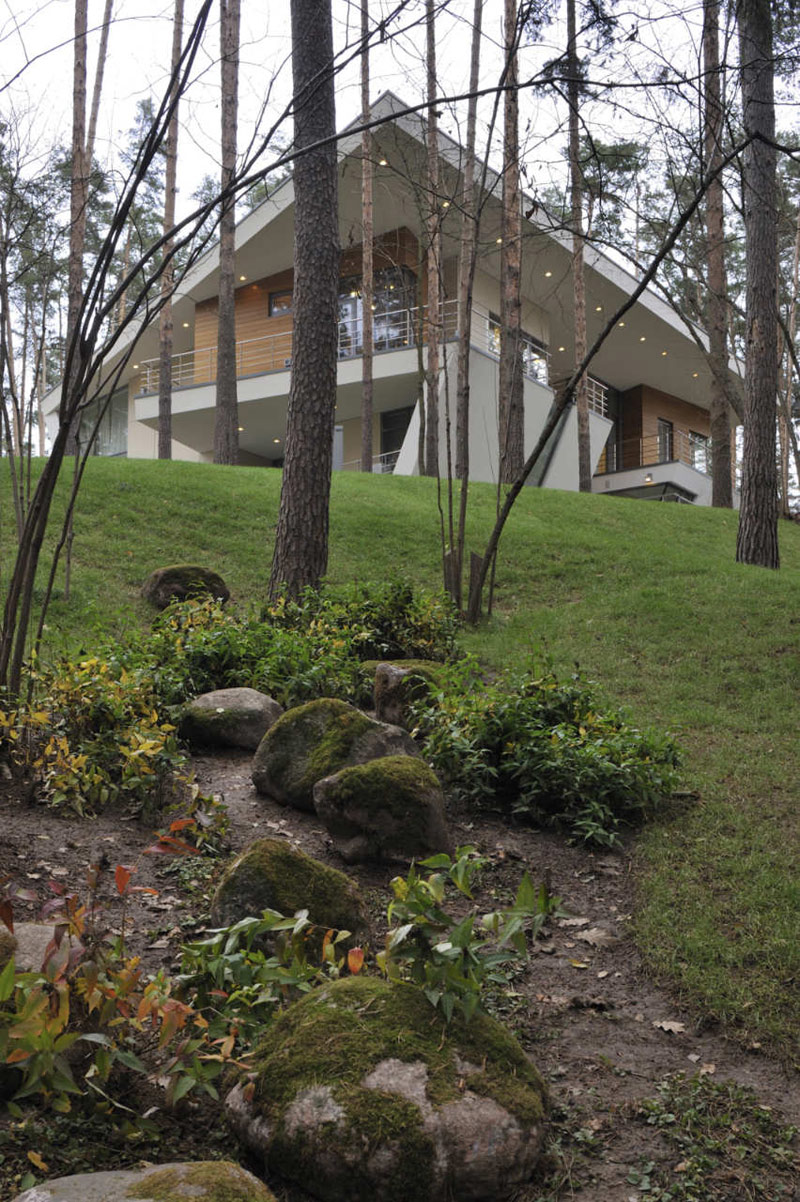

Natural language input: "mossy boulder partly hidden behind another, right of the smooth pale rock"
[252,697,419,810]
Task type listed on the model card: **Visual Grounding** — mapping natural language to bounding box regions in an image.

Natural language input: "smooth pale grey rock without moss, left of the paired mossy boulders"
[178,689,283,751]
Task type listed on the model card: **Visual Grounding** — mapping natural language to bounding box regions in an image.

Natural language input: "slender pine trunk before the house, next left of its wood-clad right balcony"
[567,0,592,493]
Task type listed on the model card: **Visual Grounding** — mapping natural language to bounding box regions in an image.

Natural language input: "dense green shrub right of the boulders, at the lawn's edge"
[413,668,677,845]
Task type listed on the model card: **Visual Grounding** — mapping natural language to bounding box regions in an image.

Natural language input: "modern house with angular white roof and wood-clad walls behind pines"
[46,94,735,504]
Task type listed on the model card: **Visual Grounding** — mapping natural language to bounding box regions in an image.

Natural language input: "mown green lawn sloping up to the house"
[1,459,800,1058]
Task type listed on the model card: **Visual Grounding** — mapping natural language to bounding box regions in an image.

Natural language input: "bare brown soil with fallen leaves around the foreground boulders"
[0,754,800,1202]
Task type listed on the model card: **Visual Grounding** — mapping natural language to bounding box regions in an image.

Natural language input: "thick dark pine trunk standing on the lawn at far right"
[736,0,780,567]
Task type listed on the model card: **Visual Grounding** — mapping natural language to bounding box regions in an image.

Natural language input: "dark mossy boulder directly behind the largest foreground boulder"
[206,839,366,934]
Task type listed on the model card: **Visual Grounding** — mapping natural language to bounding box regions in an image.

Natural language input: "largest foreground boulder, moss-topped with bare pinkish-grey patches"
[227,977,545,1202]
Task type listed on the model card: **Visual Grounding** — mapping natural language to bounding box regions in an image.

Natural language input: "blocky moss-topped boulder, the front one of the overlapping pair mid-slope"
[314,755,453,863]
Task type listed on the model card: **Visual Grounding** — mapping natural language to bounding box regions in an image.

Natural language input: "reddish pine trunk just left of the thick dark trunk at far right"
[703,0,733,510]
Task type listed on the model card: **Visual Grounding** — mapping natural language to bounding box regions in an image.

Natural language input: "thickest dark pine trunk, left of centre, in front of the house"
[269,0,339,596]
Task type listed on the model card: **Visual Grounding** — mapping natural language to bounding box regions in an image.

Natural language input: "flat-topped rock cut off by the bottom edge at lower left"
[9,1160,275,1202]
